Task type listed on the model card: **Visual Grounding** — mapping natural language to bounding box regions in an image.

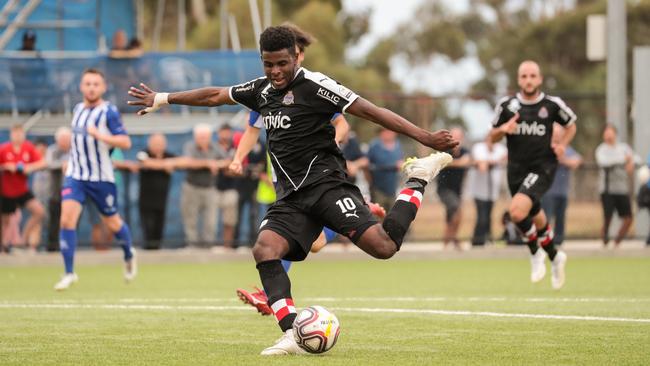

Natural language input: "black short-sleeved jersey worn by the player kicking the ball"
[229,68,358,200]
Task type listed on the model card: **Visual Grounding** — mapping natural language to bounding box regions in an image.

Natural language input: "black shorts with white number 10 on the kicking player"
[259,181,378,261]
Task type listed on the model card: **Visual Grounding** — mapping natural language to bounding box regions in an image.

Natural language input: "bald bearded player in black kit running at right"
[490,61,576,289]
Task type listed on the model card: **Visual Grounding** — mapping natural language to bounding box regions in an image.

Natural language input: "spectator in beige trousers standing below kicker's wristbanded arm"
[177,124,227,245]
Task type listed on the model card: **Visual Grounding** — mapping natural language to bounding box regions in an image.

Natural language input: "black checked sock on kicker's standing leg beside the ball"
[257,259,296,332]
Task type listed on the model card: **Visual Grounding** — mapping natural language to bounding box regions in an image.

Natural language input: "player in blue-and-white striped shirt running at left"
[54,69,137,291]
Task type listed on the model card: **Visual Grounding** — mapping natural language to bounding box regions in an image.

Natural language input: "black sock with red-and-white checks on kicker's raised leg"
[382,178,427,250]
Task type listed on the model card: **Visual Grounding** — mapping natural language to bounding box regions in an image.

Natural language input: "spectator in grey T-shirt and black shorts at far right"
[596,124,634,247]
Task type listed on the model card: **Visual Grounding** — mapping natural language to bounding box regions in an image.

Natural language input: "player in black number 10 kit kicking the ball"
[129,27,458,355]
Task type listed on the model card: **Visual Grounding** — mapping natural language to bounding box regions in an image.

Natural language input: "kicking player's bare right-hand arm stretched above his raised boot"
[347,97,458,151]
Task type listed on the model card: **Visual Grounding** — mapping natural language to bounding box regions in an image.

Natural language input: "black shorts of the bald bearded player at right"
[508,162,557,204]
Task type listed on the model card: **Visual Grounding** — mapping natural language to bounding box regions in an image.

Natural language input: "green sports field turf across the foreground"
[0,257,650,366]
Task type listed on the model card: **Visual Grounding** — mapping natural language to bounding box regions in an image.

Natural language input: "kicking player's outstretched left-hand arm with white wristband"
[128,83,235,115]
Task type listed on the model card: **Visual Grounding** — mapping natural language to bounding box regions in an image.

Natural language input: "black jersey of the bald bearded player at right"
[492,93,577,165]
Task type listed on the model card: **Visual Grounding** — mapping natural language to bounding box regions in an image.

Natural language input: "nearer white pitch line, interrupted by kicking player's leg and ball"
[0,303,650,324]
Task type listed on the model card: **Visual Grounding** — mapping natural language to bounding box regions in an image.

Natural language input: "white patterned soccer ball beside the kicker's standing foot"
[293,305,341,353]
